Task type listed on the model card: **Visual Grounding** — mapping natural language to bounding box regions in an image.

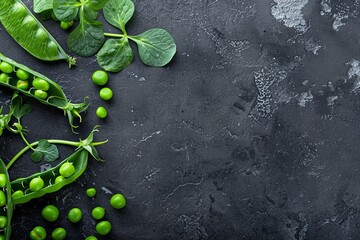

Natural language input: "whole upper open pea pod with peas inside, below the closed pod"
[0,53,88,131]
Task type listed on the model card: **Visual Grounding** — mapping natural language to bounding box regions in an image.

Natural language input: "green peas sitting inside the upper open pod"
[0,61,50,100]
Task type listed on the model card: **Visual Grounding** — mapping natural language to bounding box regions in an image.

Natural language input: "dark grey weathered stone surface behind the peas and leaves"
[0,0,360,240]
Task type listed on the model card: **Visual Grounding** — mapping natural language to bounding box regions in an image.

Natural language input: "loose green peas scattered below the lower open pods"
[30,188,126,240]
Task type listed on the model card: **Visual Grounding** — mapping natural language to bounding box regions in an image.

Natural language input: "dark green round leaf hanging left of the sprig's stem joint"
[67,12,105,57]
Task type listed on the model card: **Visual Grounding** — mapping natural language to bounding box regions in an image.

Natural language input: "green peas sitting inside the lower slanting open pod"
[11,162,75,199]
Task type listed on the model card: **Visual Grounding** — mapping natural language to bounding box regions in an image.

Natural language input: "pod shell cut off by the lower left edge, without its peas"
[0,159,13,240]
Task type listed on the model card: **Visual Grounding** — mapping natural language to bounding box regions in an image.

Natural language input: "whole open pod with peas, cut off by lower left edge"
[0,159,13,240]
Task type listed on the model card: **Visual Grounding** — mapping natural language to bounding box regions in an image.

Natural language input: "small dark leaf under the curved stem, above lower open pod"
[31,139,59,162]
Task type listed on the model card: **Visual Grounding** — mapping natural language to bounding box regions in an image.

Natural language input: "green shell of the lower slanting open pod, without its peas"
[11,148,88,205]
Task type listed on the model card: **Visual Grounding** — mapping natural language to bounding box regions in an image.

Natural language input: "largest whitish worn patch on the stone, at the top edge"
[271,0,308,32]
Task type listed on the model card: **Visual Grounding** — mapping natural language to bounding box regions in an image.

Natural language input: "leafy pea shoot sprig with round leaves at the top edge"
[34,0,176,72]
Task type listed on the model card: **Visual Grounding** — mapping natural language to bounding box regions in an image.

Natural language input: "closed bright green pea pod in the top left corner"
[0,0,75,66]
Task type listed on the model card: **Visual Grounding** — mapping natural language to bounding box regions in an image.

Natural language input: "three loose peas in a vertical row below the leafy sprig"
[91,70,113,119]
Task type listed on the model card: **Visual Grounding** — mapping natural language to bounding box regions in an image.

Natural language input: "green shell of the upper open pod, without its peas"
[0,53,88,131]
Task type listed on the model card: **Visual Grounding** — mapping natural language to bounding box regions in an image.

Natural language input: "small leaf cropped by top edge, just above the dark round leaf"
[53,0,82,22]
